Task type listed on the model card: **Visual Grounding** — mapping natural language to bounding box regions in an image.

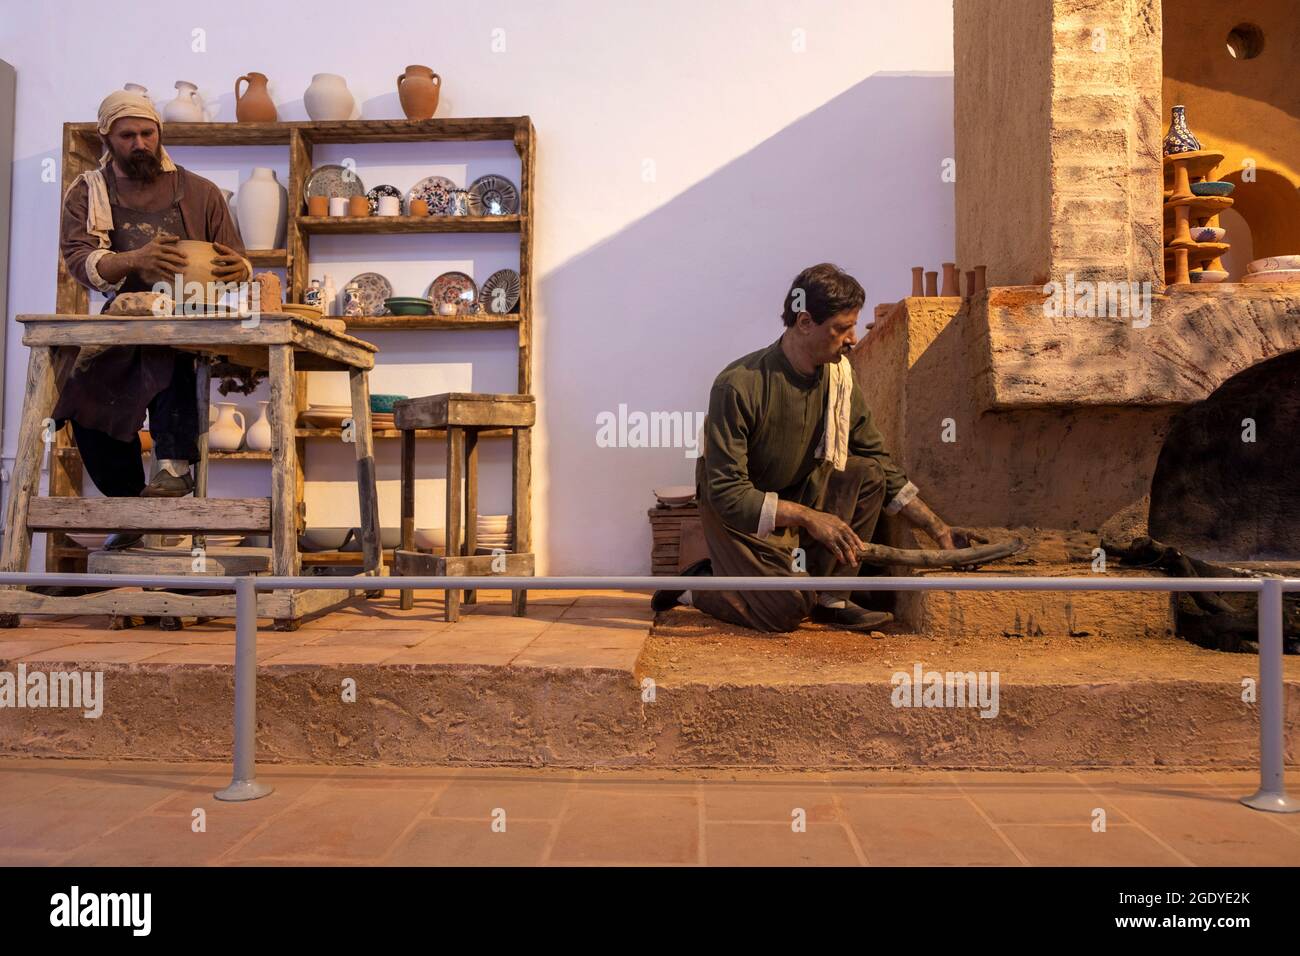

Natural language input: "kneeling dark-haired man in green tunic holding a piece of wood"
[653,263,970,632]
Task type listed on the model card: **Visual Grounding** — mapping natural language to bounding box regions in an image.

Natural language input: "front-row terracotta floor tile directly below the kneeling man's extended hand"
[839,795,1019,866]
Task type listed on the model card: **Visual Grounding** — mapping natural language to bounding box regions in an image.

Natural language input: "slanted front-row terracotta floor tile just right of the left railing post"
[222,783,429,862]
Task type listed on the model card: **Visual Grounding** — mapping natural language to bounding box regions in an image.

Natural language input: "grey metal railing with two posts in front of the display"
[0,572,1300,813]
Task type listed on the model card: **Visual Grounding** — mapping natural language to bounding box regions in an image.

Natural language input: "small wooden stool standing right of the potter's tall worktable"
[393,392,537,620]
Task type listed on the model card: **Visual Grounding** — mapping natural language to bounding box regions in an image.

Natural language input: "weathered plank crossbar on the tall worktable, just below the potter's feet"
[27,498,270,535]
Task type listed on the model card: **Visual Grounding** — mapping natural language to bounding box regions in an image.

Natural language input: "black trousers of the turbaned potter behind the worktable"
[72,352,199,498]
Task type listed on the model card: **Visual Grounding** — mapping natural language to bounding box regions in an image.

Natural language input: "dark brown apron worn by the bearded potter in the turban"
[53,166,193,441]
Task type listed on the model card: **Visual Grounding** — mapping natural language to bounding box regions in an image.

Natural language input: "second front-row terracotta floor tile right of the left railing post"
[384,816,554,866]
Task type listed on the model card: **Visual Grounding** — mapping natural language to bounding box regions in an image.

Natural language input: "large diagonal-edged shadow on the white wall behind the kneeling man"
[533,74,954,574]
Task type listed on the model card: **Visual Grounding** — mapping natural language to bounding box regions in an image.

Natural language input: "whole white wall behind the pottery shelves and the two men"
[0,0,953,574]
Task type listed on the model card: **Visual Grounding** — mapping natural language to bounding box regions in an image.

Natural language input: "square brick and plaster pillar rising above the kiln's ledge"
[954,0,1164,285]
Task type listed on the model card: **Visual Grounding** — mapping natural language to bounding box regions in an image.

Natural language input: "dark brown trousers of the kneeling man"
[692,455,885,632]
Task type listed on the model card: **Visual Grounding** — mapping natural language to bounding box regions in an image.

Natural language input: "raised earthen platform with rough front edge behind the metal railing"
[0,582,1300,769]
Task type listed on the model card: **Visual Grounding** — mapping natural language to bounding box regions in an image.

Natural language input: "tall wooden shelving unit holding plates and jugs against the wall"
[46,116,536,571]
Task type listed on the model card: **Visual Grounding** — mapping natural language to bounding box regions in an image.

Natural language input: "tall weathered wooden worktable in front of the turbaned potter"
[0,312,382,628]
